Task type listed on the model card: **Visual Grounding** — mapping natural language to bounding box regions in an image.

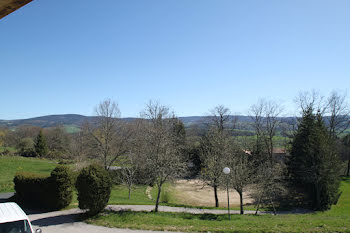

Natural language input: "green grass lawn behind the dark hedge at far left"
[0,156,57,192]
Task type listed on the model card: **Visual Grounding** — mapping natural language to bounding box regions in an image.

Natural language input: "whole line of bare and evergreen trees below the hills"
[0,92,350,214]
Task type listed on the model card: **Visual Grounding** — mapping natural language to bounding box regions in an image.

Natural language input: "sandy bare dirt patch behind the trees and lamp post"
[174,180,253,207]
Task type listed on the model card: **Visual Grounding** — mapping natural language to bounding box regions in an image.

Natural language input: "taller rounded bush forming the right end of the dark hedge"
[48,165,73,209]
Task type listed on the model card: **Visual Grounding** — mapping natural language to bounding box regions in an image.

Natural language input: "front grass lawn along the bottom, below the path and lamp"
[87,178,350,232]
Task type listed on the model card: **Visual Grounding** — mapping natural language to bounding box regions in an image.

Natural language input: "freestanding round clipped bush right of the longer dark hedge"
[75,164,112,215]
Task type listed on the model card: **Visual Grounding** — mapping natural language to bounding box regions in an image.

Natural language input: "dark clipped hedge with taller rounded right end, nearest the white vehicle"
[13,166,73,210]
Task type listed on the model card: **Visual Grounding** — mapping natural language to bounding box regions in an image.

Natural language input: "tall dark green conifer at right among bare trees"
[289,108,340,210]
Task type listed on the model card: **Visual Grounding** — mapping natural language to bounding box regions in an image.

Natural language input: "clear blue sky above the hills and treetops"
[0,0,350,119]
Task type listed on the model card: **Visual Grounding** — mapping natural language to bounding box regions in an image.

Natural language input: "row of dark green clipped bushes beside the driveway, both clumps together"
[14,162,112,215]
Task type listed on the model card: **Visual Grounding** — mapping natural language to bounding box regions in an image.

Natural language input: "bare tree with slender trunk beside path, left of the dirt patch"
[142,101,185,212]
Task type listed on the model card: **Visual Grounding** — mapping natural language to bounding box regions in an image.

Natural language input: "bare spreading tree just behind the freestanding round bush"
[88,99,131,169]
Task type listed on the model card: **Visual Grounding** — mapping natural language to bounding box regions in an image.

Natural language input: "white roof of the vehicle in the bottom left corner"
[0,202,28,223]
